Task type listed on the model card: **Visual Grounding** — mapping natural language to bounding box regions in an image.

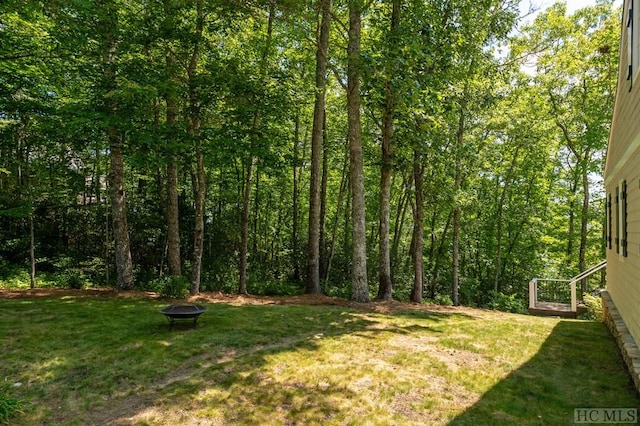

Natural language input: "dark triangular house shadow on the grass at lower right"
[450,321,640,425]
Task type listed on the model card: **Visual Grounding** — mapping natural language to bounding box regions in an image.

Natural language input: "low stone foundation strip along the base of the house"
[600,290,640,392]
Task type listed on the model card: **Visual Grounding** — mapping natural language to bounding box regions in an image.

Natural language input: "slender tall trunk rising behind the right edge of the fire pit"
[187,0,207,295]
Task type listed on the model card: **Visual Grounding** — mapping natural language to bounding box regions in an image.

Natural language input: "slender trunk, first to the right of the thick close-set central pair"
[411,150,424,303]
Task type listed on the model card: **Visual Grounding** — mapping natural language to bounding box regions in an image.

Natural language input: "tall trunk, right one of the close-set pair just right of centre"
[376,0,400,300]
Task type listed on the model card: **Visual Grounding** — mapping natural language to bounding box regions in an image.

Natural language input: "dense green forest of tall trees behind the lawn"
[0,0,620,306]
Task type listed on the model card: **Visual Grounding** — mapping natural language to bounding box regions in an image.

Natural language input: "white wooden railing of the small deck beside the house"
[529,260,607,312]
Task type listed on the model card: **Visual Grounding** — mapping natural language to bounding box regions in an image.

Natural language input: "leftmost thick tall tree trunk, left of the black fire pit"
[101,0,134,290]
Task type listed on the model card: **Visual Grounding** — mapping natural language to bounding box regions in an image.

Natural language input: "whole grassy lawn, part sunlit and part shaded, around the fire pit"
[0,296,640,425]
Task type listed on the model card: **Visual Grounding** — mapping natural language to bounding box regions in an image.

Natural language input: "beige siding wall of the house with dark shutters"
[604,0,640,352]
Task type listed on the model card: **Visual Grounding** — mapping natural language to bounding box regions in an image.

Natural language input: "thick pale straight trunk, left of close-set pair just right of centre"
[347,0,370,303]
